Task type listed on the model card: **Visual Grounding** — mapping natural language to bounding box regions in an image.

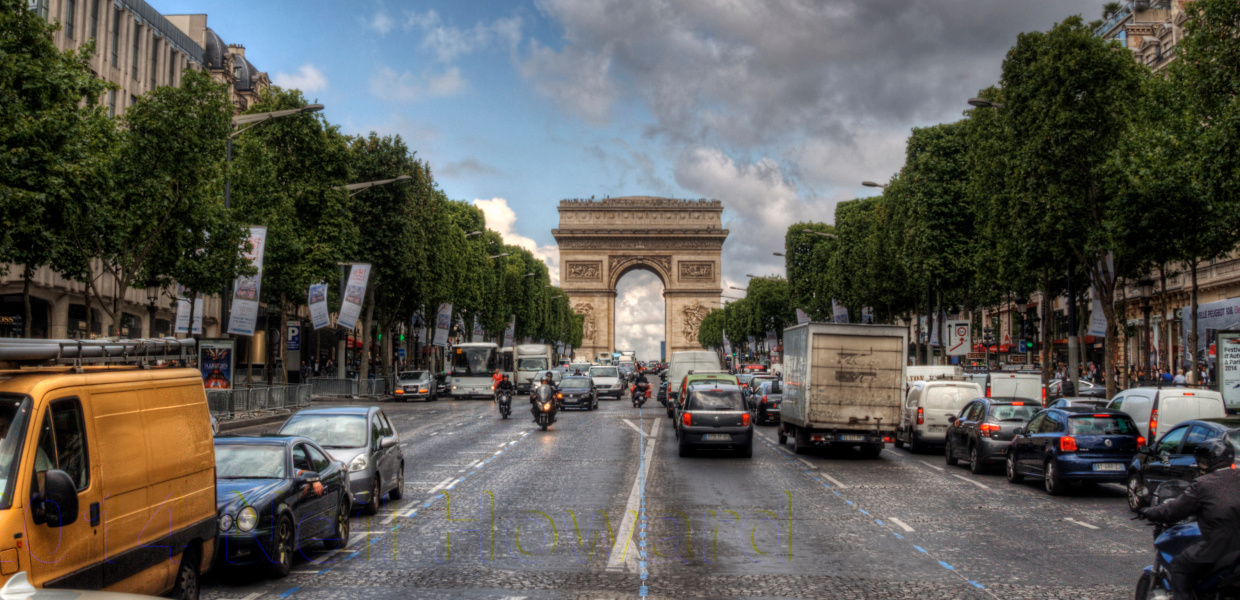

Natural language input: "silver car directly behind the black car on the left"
[279,407,404,514]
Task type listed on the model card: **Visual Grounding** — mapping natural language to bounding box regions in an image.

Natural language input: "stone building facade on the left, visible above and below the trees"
[0,0,270,338]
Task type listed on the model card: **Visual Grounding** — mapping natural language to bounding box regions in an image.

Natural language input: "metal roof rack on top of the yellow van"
[0,337,196,368]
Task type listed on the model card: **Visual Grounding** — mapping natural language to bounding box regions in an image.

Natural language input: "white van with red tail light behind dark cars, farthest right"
[1106,387,1228,444]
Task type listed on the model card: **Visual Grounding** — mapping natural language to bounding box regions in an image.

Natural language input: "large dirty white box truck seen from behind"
[779,322,909,456]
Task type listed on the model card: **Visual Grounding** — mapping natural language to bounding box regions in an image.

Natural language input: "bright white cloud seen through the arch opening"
[615,270,666,361]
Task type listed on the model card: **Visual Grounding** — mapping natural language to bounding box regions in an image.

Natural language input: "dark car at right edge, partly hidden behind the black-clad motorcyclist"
[1126,417,1240,512]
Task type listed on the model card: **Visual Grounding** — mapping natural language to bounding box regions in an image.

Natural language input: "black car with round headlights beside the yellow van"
[215,435,351,578]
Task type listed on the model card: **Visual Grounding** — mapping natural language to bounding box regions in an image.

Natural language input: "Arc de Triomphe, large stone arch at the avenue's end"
[552,196,728,360]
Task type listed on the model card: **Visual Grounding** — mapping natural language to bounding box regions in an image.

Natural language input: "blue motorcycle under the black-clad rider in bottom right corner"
[1136,480,1240,600]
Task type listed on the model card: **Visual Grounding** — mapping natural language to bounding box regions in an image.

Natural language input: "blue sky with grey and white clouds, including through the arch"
[157,0,1102,357]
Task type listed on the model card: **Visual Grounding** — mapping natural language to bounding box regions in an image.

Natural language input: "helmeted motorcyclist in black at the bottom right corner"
[1138,439,1240,600]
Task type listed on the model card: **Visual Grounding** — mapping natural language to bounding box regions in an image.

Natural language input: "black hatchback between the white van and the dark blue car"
[944,398,1042,474]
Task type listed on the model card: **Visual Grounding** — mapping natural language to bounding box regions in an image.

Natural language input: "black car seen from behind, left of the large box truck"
[676,384,754,459]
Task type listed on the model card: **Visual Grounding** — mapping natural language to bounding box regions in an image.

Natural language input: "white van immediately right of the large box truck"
[895,379,982,452]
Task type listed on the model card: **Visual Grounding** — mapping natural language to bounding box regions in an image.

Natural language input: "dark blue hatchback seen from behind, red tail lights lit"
[1007,407,1141,496]
